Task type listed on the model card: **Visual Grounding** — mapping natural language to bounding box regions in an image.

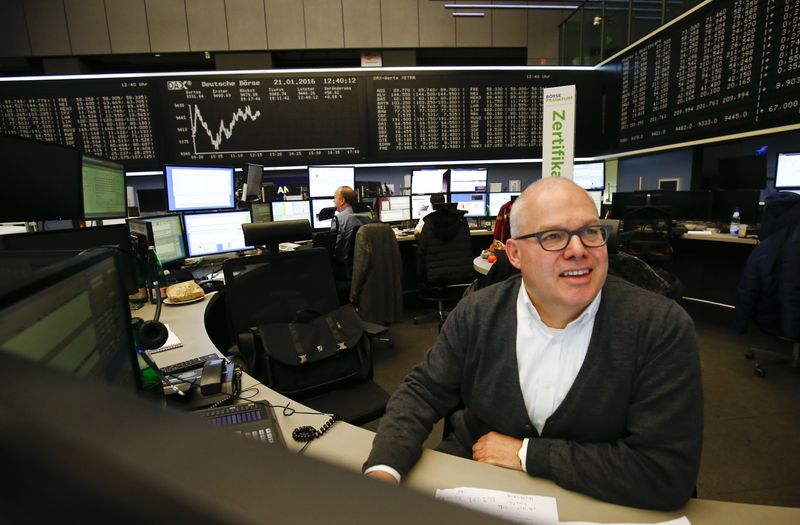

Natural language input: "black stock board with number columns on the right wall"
[608,0,800,150]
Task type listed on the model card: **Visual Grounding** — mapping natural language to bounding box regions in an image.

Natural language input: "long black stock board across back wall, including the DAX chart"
[0,68,616,171]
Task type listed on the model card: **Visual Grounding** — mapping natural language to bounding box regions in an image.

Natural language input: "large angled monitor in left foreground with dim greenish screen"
[0,249,141,388]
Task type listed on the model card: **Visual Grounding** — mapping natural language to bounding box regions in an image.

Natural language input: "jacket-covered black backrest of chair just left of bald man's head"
[417,208,474,286]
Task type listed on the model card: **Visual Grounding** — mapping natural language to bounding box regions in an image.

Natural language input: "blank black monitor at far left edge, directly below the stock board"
[0,135,83,222]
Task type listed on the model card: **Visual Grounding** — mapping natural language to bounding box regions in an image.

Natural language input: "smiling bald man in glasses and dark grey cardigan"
[364,178,703,509]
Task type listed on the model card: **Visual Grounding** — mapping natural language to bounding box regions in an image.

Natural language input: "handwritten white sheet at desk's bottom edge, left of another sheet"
[436,487,558,525]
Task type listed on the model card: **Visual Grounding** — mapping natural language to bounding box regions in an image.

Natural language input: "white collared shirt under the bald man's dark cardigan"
[517,283,602,470]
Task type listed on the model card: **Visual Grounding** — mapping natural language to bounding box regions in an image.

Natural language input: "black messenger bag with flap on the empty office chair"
[239,305,372,399]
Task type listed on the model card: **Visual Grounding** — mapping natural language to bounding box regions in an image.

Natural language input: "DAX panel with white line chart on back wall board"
[165,76,372,164]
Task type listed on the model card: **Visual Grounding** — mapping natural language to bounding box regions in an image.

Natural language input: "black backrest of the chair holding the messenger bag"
[223,248,339,334]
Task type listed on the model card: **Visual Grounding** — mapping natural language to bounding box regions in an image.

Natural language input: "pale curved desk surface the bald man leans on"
[136,297,800,525]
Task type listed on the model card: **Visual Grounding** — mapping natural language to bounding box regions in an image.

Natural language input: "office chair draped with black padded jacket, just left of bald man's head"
[413,203,475,327]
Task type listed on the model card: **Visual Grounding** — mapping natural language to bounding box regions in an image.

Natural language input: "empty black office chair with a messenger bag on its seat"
[223,248,388,425]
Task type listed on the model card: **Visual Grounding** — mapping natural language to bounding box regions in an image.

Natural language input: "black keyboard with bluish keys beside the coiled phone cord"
[195,403,286,446]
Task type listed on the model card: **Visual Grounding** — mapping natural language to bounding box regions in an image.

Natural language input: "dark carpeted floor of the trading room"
[365,295,800,507]
